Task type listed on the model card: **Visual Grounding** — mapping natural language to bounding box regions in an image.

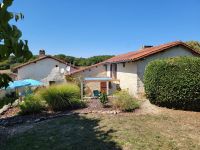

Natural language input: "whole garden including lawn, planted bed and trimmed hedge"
[0,57,200,150]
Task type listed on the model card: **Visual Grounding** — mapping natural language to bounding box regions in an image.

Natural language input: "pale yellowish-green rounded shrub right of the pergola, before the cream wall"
[112,91,139,111]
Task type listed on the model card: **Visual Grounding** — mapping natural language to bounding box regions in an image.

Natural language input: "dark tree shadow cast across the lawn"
[2,114,121,150]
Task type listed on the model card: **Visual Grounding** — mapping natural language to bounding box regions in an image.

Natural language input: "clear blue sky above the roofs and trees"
[10,0,200,57]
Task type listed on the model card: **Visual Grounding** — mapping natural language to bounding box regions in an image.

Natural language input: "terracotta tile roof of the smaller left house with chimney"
[12,55,78,70]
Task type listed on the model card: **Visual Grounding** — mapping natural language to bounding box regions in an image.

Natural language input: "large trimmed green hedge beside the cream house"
[144,57,200,111]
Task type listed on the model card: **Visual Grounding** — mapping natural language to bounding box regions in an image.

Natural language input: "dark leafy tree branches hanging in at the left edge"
[0,0,32,88]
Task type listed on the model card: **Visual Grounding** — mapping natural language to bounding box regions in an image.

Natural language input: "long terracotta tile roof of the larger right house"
[67,41,200,75]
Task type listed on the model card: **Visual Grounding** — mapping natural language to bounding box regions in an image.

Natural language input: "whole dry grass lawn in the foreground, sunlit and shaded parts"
[0,107,200,150]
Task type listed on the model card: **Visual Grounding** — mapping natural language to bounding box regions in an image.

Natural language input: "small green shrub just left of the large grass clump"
[19,94,45,115]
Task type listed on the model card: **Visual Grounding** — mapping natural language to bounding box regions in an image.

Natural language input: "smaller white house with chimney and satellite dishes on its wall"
[13,50,77,85]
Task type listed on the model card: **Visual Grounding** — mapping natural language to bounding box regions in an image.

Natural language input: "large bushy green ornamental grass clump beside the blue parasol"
[40,84,84,111]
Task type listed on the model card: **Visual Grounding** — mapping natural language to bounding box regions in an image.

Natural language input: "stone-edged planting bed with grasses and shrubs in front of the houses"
[0,83,141,126]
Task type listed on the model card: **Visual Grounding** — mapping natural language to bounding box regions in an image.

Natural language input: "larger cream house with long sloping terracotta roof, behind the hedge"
[68,41,200,97]
